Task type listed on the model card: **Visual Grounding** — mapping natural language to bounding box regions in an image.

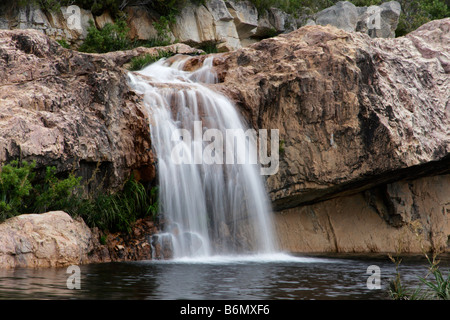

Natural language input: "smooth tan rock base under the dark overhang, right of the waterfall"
[275,174,450,253]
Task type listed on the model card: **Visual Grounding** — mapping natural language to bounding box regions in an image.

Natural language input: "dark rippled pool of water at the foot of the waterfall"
[0,255,449,300]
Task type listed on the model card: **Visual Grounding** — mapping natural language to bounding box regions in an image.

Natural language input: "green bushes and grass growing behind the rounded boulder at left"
[0,161,158,232]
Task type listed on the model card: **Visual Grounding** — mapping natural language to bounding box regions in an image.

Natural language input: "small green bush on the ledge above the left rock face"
[79,19,131,53]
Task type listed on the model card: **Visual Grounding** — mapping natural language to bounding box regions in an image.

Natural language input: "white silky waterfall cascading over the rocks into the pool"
[129,55,276,258]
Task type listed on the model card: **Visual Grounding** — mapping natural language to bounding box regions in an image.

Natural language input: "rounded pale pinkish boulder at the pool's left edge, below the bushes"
[0,211,93,268]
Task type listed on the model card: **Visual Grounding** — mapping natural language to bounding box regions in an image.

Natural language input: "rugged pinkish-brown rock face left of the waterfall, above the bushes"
[0,30,206,190]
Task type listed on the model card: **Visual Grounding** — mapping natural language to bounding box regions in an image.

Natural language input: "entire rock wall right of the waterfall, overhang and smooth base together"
[200,19,450,251]
